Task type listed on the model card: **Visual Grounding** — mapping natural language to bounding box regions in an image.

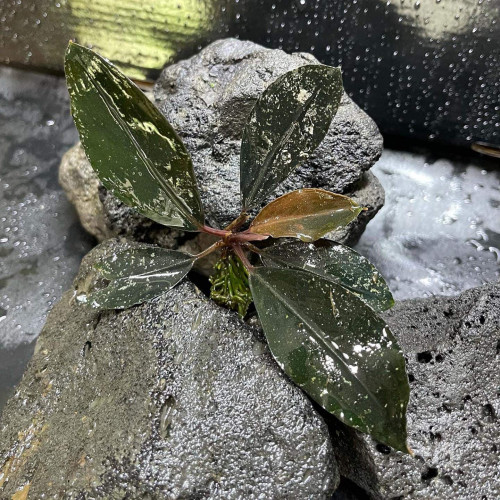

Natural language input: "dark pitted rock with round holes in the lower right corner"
[334,284,500,500]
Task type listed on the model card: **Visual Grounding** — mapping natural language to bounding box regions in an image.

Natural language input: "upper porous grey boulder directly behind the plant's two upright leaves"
[154,39,382,226]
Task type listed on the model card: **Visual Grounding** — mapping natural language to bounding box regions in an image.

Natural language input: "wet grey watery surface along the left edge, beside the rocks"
[0,66,95,410]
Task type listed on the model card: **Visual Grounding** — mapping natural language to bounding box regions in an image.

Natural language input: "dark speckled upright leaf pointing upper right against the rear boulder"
[240,64,343,209]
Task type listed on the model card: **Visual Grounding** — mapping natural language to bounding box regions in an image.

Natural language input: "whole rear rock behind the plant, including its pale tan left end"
[60,39,384,244]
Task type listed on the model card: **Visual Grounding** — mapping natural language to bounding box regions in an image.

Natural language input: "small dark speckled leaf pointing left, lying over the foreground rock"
[86,245,195,309]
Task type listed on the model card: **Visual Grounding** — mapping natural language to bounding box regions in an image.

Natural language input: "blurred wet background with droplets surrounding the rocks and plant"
[0,0,500,407]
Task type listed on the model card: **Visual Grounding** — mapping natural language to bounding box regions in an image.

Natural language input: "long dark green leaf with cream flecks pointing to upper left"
[65,43,204,231]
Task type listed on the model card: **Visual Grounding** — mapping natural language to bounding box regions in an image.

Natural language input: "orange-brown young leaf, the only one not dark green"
[250,189,362,241]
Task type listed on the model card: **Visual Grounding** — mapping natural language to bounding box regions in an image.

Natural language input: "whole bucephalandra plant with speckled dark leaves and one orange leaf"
[65,43,409,452]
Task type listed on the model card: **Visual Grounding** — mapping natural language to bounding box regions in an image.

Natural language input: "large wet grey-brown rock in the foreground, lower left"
[0,240,339,499]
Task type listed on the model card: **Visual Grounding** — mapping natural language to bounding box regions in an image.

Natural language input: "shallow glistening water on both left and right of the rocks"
[0,67,500,408]
